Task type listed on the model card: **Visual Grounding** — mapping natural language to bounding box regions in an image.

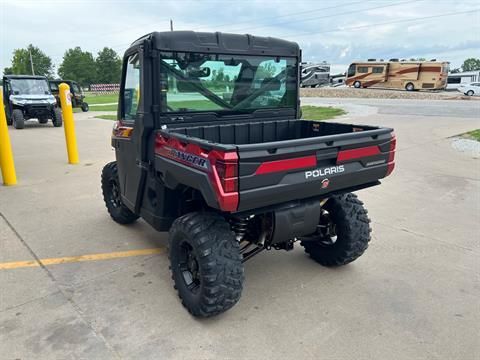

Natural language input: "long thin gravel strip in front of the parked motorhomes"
[300,87,480,101]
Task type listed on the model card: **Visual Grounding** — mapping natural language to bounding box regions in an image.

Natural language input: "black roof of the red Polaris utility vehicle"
[131,31,300,56]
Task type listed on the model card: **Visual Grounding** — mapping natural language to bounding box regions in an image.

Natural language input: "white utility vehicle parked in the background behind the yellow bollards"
[3,75,62,129]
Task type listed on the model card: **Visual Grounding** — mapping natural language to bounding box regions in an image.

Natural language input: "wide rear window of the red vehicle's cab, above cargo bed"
[161,53,297,112]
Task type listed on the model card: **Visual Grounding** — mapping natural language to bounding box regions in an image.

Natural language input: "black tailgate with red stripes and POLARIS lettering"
[237,127,395,211]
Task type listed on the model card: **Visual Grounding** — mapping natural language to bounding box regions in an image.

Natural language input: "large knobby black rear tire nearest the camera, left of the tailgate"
[168,213,244,317]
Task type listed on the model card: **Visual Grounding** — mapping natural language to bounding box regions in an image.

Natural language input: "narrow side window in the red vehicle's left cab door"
[123,54,140,120]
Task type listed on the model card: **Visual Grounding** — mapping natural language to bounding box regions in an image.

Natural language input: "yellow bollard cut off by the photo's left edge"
[0,90,17,185]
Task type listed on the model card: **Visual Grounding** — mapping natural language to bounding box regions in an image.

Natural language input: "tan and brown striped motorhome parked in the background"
[345,59,448,91]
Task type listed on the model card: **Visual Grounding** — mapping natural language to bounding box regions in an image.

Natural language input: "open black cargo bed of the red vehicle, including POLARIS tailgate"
[158,120,395,211]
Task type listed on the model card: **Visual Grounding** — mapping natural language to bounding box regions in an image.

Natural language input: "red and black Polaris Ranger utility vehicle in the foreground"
[102,31,396,317]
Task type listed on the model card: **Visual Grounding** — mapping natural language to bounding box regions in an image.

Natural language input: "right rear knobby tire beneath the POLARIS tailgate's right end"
[301,193,371,267]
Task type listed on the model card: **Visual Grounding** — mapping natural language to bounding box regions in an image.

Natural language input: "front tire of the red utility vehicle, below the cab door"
[102,161,138,225]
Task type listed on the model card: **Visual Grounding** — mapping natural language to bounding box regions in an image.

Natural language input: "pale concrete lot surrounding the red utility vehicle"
[0,98,480,359]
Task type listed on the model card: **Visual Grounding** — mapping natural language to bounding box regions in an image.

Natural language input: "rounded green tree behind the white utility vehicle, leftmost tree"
[4,44,53,77]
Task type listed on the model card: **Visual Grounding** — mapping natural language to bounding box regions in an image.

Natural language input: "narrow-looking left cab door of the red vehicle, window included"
[112,52,142,212]
